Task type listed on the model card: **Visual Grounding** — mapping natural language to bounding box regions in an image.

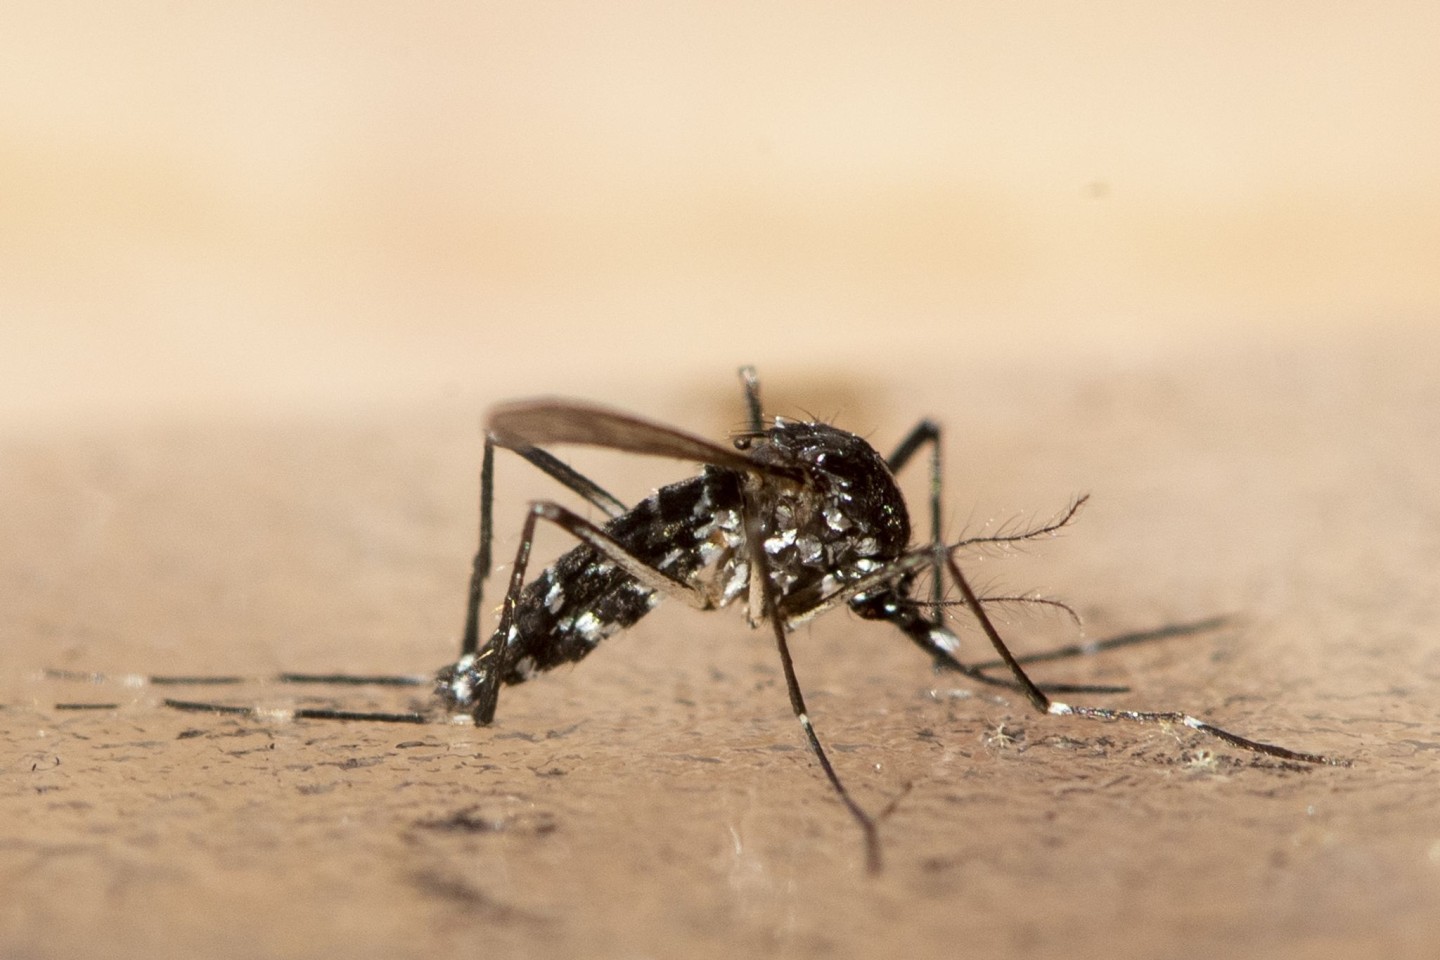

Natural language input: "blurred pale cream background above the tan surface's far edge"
[0,1,1440,429]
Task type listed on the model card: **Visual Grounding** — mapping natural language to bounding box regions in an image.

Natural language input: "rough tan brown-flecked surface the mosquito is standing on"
[8,340,1440,957]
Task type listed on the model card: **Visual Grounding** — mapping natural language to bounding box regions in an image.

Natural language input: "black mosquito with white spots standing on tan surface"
[53,367,1338,871]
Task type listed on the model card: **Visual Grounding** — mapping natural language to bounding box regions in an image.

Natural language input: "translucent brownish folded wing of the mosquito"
[487,400,805,481]
